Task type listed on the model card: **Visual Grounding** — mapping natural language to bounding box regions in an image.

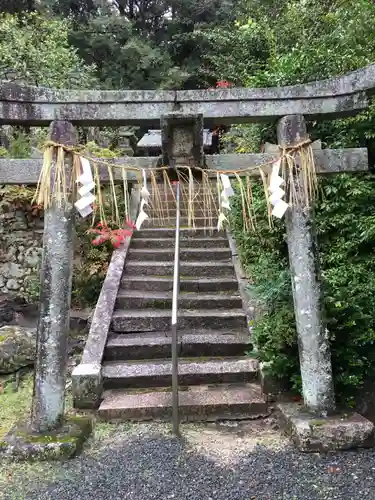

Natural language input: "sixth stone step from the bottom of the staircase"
[121,273,238,293]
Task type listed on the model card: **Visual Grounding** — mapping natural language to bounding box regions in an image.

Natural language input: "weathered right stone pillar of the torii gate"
[277,115,335,415]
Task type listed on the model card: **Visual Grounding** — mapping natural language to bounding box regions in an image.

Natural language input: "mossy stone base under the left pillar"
[0,416,93,461]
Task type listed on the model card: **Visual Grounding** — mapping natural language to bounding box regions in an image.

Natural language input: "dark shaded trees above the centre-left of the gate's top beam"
[34,0,241,89]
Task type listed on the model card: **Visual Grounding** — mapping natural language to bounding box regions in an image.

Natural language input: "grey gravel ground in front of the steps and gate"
[0,421,375,500]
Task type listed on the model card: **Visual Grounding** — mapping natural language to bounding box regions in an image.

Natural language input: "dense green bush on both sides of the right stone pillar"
[232,174,375,404]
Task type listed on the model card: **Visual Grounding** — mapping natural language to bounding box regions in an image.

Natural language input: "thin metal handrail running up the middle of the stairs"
[171,182,180,436]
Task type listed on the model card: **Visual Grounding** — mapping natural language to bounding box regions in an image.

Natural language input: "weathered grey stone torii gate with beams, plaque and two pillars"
[0,65,375,456]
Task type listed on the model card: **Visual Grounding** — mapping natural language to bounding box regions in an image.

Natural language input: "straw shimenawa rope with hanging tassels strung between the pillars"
[34,140,317,231]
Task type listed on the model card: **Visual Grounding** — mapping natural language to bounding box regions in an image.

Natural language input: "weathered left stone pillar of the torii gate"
[31,121,77,433]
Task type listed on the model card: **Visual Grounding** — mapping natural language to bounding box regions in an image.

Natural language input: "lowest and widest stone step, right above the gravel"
[98,383,269,422]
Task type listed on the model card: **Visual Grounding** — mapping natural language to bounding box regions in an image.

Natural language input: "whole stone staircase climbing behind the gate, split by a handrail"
[98,186,268,421]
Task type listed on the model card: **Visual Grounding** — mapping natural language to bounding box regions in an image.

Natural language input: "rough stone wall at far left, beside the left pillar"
[0,205,43,297]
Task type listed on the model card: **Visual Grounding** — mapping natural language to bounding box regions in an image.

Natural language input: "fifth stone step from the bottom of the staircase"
[116,290,242,310]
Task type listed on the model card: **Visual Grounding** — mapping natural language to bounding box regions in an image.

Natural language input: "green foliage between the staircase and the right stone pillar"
[231,182,298,390]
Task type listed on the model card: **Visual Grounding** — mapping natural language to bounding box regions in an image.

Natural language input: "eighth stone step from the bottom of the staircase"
[127,247,232,265]
